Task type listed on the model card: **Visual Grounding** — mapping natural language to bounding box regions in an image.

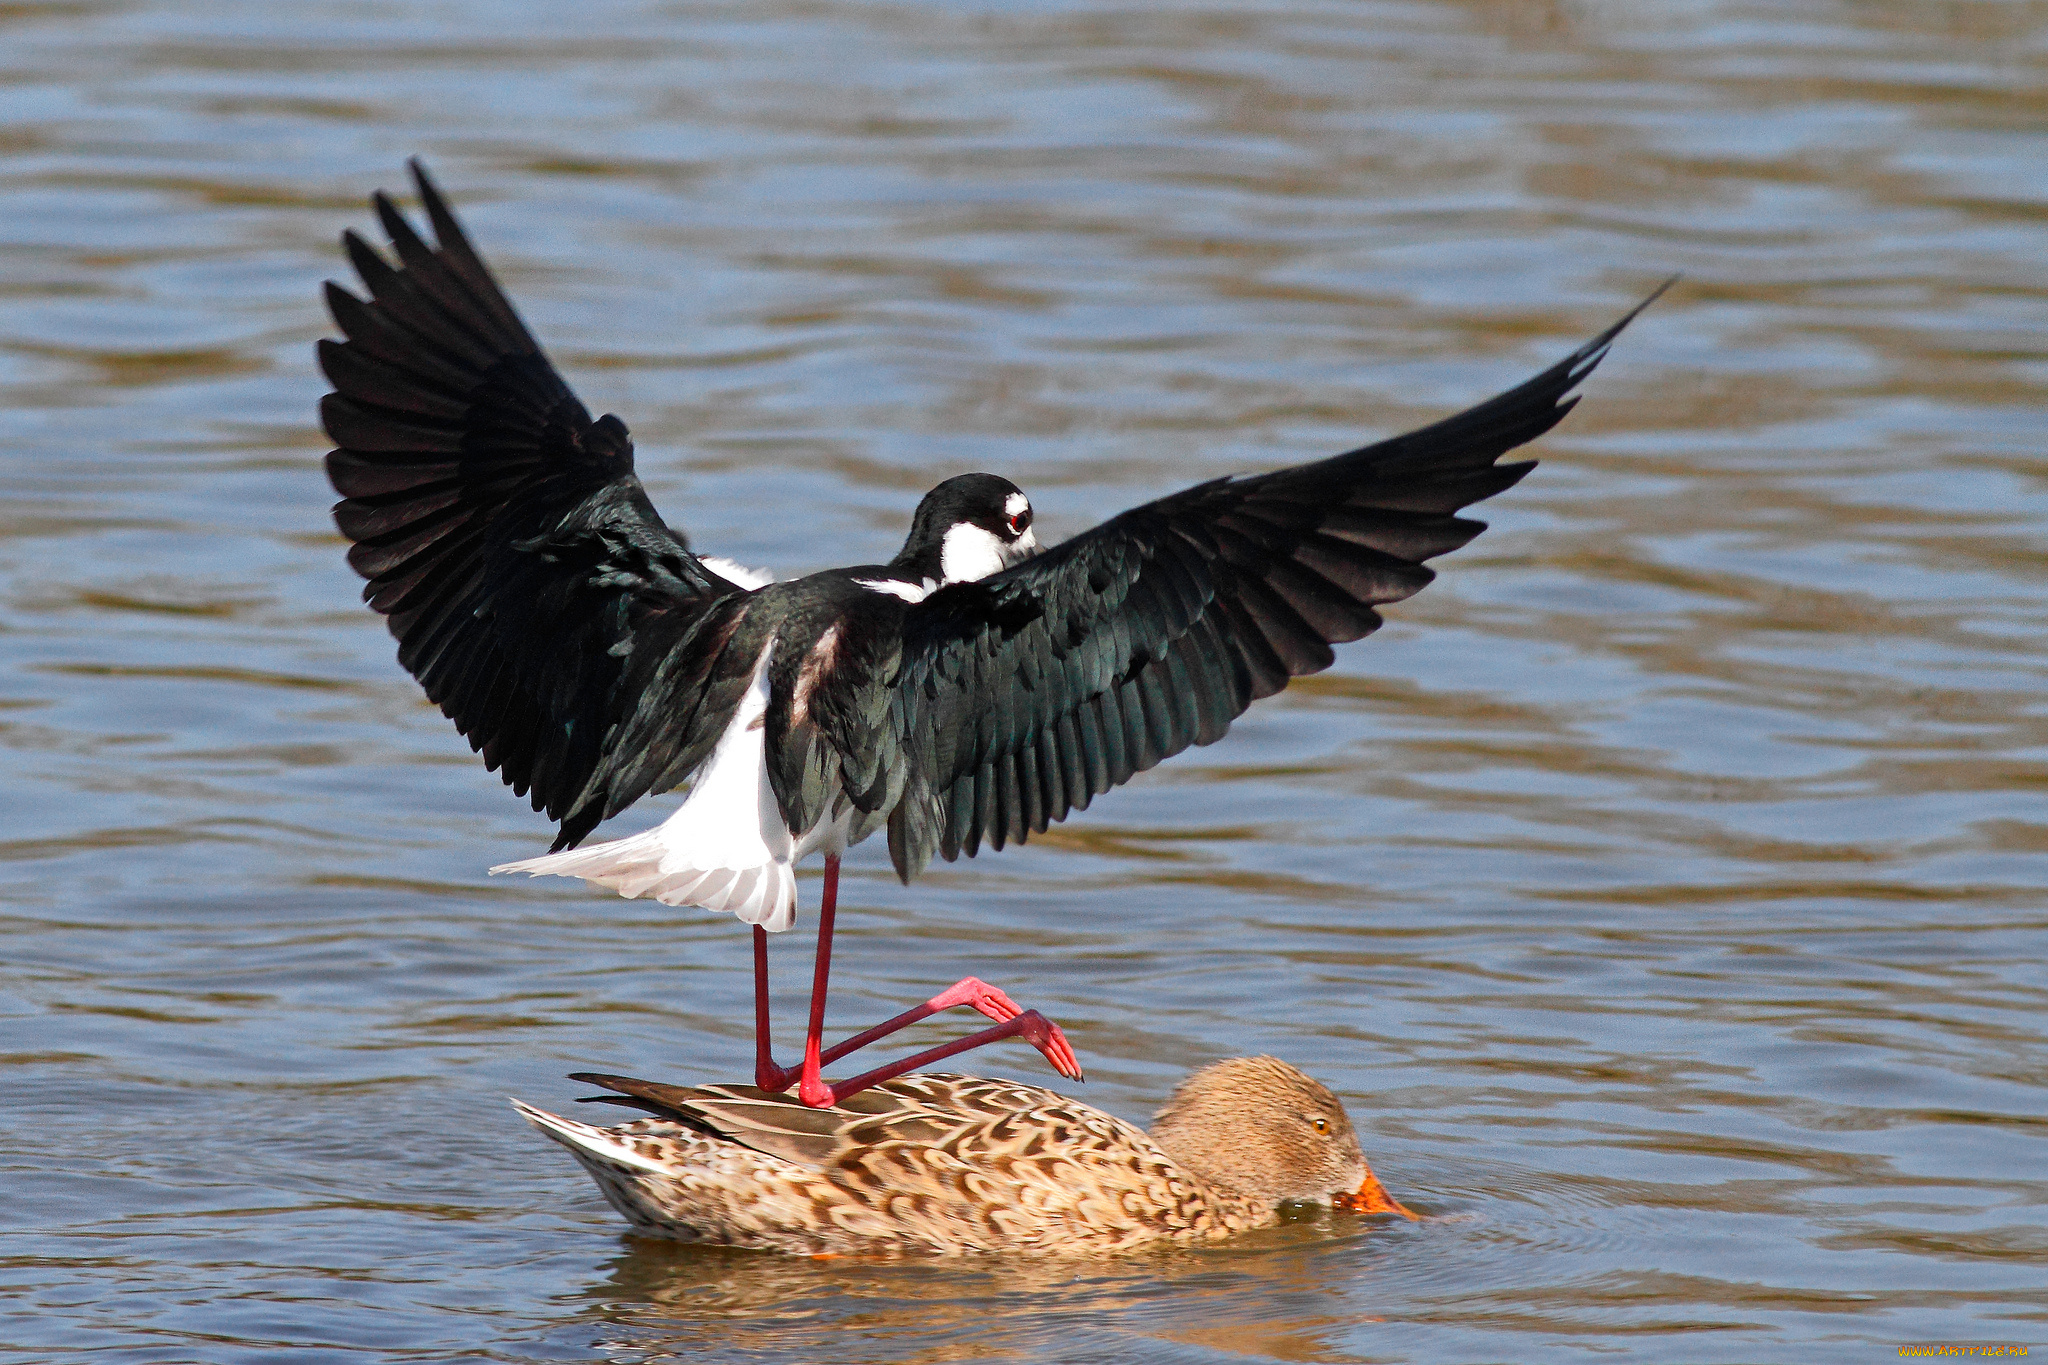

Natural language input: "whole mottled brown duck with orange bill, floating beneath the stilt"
[512,1056,1419,1257]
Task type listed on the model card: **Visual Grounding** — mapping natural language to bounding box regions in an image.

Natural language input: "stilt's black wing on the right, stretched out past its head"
[889,289,1663,880]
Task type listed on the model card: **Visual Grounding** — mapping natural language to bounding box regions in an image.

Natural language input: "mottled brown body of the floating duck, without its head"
[520,1074,1264,1252]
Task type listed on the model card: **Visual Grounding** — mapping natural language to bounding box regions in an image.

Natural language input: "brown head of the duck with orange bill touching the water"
[1151,1056,1415,1218]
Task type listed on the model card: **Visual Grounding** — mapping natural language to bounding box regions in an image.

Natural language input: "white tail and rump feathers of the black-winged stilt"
[492,645,852,933]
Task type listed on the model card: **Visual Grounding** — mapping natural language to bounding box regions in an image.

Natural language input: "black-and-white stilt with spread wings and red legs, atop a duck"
[319,162,1663,1105]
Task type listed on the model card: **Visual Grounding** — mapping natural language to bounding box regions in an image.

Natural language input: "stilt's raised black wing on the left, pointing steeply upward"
[319,162,754,849]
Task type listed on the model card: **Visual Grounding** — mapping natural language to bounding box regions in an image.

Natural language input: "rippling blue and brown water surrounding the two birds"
[0,0,2048,1363]
